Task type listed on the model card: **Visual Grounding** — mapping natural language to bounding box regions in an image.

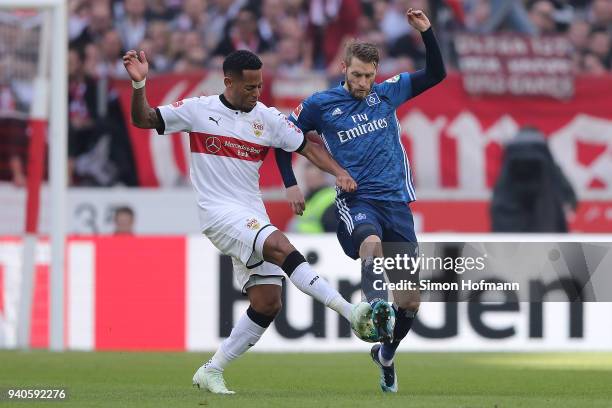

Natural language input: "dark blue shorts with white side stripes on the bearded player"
[336,197,417,259]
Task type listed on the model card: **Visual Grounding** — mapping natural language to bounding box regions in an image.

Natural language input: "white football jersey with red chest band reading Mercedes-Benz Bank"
[157,95,305,230]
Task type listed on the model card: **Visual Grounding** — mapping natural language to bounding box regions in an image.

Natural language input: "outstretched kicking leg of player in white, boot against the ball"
[262,230,376,339]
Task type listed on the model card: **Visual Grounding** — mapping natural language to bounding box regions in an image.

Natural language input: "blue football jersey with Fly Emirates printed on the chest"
[290,73,416,202]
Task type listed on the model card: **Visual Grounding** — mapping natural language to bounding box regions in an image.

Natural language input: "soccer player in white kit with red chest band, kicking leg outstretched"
[123,50,376,394]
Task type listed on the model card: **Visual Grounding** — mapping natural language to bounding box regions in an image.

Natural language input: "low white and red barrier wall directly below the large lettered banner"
[0,186,612,236]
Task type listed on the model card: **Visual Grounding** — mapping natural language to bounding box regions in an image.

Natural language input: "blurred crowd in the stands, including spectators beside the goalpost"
[0,0,612,186]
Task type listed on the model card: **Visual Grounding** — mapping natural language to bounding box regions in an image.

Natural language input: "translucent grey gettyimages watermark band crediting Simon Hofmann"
[362,242,612,302]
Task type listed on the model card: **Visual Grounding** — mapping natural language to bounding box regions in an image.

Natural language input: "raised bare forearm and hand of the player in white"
[123,50,162,129]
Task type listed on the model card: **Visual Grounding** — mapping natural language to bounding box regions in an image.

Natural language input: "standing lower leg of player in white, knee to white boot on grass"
[193,282,282,394]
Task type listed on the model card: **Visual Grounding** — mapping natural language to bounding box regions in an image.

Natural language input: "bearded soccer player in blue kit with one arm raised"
[276,8,446,392]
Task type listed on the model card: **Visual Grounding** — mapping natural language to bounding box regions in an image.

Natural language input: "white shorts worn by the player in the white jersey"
[203,208,285,293]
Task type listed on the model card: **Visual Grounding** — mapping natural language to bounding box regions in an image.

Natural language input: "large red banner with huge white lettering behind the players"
[117,73,612,196]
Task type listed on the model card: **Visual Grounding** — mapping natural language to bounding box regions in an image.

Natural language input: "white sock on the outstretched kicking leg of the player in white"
[290,262,353,321]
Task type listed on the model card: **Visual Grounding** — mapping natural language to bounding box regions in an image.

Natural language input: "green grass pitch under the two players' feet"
[0,351,612,408]
